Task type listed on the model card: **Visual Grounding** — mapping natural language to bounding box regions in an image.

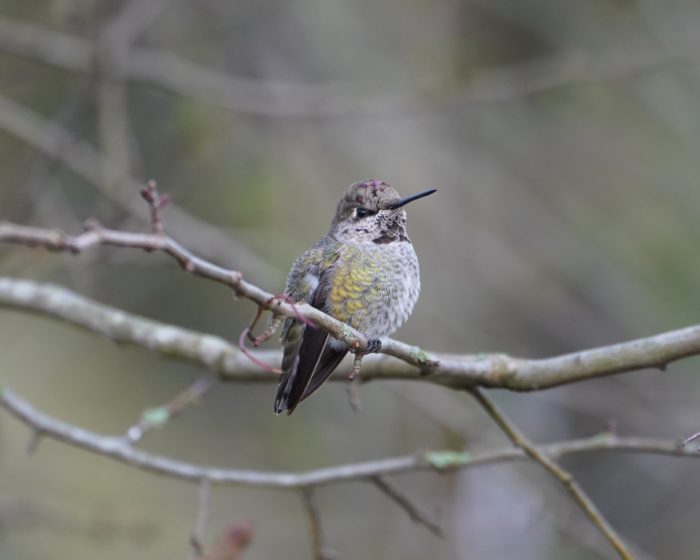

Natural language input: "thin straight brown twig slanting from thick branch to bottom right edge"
[471,388,634,560]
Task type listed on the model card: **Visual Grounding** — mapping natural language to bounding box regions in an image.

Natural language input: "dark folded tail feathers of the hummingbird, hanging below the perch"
[275,325,346,414]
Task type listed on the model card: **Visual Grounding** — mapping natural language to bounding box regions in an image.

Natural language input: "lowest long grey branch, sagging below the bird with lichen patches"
[0,388,700,491]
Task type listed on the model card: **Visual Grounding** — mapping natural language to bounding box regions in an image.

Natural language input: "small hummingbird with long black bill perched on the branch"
[274,179,437,414]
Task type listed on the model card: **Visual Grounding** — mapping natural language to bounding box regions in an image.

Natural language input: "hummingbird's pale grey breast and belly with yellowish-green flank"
[327,241,420,338]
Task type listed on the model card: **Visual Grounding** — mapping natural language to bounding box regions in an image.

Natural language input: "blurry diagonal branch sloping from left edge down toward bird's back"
[0,96,277,278]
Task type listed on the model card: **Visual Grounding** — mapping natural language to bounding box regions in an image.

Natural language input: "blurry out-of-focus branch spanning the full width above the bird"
[0,14,700,117]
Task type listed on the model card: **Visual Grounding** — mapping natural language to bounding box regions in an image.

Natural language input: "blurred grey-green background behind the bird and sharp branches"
[0,0,700,560]
